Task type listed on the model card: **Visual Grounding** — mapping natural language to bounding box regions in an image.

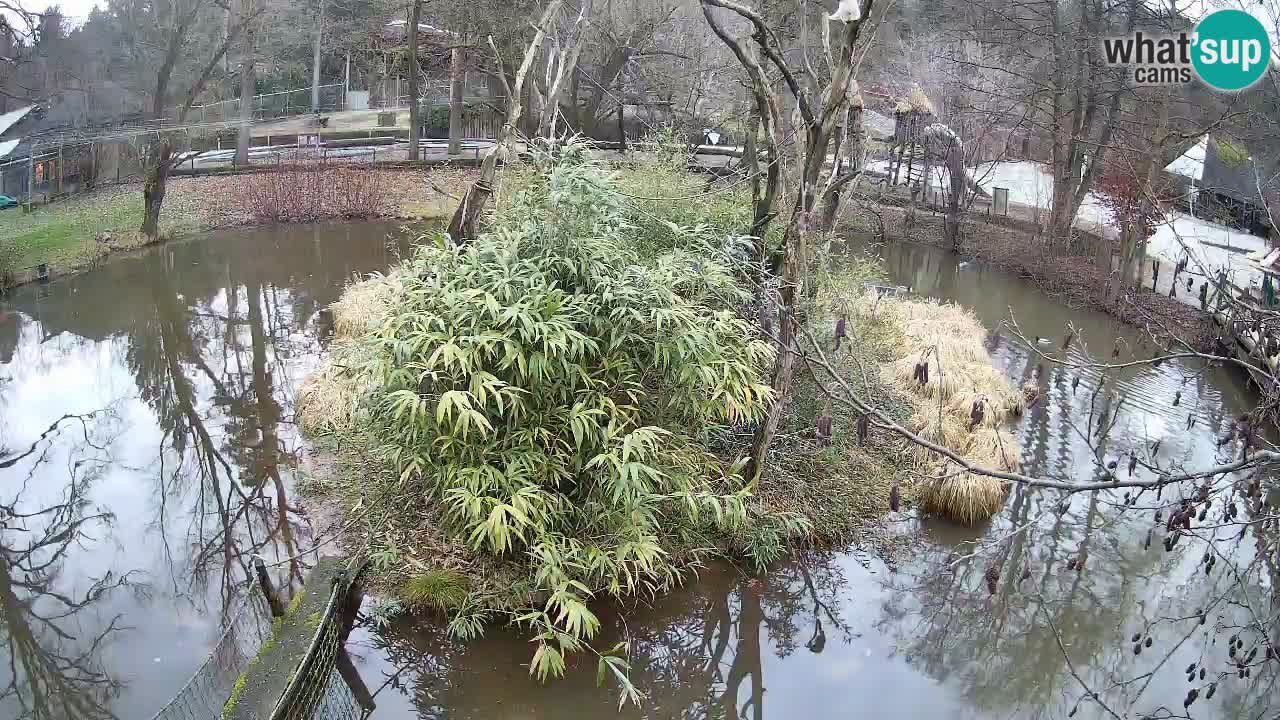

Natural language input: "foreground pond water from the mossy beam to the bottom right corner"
[356,474,1280,720]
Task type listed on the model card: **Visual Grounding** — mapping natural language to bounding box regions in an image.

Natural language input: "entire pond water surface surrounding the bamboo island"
[0,225,1280,720]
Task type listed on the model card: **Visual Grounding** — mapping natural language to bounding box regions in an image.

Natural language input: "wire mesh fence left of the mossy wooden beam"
[152,589,271,720]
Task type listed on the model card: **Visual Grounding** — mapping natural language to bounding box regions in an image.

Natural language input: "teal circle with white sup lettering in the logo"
[1192,10,1271,90]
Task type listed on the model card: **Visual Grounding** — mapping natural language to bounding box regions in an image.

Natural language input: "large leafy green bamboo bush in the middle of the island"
[353,142,772,679]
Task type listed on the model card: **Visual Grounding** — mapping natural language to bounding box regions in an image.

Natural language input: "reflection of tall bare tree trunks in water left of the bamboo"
[128,248,327,618]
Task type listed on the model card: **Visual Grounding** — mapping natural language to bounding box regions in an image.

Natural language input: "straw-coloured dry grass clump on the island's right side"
[856,292,1023,525]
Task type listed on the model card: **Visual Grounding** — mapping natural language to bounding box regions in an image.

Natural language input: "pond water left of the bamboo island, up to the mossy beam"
[0,225,409,720]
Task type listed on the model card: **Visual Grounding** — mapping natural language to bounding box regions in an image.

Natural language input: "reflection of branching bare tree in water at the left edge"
[0,411,135,720]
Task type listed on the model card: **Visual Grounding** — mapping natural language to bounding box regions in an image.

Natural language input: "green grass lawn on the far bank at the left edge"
[0,187,197,270]
